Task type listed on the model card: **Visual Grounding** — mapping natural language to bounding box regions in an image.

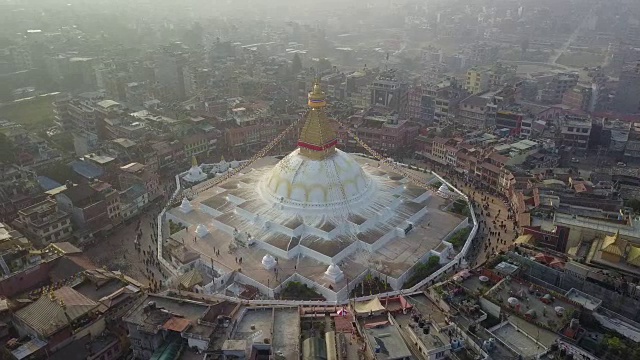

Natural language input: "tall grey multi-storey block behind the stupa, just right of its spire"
[370,70,409,114]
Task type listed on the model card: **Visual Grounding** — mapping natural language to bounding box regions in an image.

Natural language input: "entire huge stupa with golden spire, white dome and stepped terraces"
[168,81,467,300]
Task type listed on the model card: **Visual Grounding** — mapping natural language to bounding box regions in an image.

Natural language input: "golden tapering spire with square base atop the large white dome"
[298,79,338,160]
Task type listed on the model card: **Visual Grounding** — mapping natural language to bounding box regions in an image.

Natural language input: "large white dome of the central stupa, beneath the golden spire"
[261,149,374,209]
